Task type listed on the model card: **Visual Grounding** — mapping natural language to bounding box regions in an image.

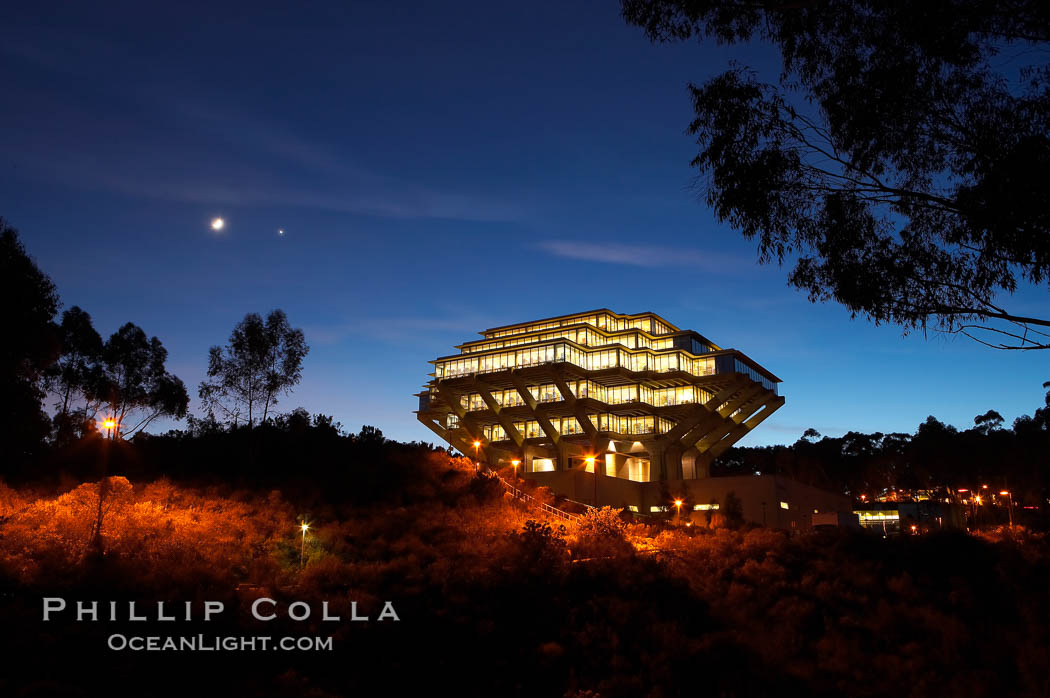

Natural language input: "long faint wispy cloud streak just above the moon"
[8,124,520,221]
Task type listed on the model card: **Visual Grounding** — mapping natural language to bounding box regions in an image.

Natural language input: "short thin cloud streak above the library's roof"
[539,240,755,273]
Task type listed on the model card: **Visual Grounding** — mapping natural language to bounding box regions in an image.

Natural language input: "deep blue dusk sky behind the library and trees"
[0,2,1050,445]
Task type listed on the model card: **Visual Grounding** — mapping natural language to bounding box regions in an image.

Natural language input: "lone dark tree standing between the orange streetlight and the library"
[200,310,310,428]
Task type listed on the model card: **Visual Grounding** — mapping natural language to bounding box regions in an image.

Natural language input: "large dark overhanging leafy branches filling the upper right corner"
[623,0,1050,350]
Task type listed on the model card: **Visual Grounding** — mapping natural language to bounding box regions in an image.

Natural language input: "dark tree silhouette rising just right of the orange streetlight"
[98,322,189,438]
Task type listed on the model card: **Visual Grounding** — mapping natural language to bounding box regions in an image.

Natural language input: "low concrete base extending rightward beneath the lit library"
[525,469,852,532]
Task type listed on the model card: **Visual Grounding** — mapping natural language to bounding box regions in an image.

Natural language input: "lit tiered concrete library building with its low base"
[417,309,849,529]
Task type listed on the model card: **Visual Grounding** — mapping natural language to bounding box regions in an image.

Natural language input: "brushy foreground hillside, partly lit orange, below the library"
[0,430,1050,698]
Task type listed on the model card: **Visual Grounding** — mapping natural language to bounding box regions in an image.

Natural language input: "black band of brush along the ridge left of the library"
[18,407,457,508]
